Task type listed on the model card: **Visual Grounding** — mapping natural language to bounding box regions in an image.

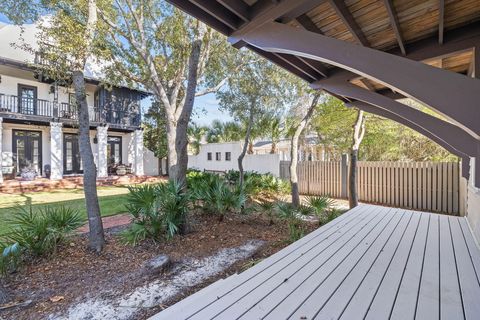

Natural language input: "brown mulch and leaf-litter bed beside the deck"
[0,215,317,319]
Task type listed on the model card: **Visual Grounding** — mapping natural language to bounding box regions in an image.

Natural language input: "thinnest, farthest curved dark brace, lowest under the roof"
[345,101,470,180]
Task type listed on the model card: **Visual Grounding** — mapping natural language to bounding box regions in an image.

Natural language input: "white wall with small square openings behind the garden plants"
[188,142,280,176]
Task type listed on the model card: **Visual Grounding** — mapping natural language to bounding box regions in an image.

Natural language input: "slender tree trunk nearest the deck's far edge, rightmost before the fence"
[348,110,365,209]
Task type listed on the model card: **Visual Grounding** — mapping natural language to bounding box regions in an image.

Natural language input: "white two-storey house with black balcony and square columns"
[0,24,151,181]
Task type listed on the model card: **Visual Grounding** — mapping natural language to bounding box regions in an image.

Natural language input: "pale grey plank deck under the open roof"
[152,205,480,320]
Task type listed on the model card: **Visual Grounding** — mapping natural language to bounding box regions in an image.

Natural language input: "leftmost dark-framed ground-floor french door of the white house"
[12,130,42,175]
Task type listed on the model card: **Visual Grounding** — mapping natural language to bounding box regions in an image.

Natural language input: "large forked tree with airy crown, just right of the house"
[99,0,248,183]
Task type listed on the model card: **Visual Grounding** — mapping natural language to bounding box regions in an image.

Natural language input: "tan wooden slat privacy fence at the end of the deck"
[280,157,464,214]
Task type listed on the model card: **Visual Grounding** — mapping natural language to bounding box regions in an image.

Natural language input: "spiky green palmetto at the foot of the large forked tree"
[122,181,190,245]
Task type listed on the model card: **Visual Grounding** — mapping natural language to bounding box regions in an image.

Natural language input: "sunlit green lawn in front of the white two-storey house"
[0,186,132,234]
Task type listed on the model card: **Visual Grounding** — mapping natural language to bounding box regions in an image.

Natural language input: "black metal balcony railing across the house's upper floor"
[0,93,140,126]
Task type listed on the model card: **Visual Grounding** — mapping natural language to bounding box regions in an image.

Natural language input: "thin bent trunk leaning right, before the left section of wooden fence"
[290,92,321,208]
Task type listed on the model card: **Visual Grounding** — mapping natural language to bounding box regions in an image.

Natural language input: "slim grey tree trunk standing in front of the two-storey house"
[72,71,105,252]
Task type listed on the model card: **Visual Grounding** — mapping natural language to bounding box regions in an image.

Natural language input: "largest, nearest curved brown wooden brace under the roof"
[229,22,480,139]
